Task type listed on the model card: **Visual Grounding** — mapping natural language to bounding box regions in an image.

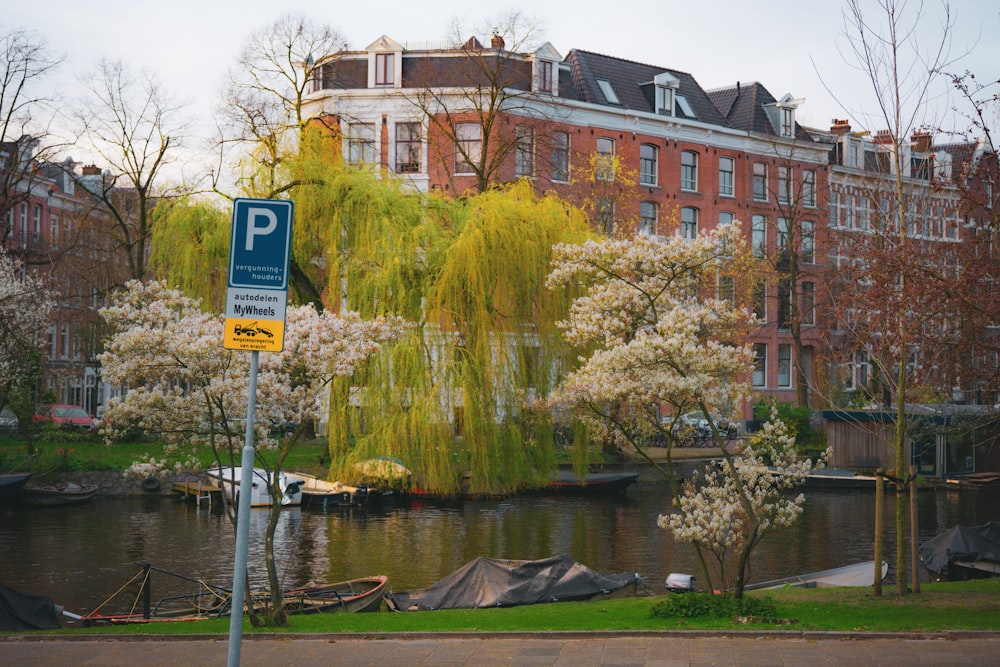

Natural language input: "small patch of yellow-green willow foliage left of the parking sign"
[150,200,231,312]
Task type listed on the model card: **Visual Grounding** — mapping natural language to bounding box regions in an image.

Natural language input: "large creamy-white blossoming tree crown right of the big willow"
[548,226,752,481]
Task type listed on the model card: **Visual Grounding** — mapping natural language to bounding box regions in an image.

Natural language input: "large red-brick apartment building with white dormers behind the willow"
[306,36,830,416]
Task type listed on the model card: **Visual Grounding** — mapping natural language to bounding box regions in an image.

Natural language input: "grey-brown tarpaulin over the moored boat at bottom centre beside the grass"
[386,554,639,611]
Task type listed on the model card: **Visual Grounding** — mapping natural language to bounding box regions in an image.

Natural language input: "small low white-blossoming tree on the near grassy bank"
[657,411,822,599]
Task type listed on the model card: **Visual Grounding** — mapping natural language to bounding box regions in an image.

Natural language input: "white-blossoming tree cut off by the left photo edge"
[0,247,52,453]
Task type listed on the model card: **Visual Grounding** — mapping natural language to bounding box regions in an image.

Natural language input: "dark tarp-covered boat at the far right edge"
[919,521,1000,581]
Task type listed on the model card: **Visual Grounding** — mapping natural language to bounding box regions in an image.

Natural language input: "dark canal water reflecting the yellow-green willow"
[0,482,1000,613]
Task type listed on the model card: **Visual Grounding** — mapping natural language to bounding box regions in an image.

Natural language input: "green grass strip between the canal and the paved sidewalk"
[25,579,1000,635]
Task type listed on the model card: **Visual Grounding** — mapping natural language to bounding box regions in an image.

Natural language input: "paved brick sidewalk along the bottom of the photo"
[0,633,1000,667]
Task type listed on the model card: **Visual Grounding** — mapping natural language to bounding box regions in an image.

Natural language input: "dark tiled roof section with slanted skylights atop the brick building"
[560,49,729,126]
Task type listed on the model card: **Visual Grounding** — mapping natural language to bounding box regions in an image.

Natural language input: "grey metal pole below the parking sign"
[226,351,260,667]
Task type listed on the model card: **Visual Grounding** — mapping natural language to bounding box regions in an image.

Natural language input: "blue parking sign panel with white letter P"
[229,199,292,289]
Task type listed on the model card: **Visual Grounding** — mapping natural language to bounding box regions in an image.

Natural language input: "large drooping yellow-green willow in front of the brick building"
[330,177,589,493]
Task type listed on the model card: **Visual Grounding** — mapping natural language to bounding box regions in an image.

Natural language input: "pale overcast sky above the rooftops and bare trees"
[0,0,1000,159]
